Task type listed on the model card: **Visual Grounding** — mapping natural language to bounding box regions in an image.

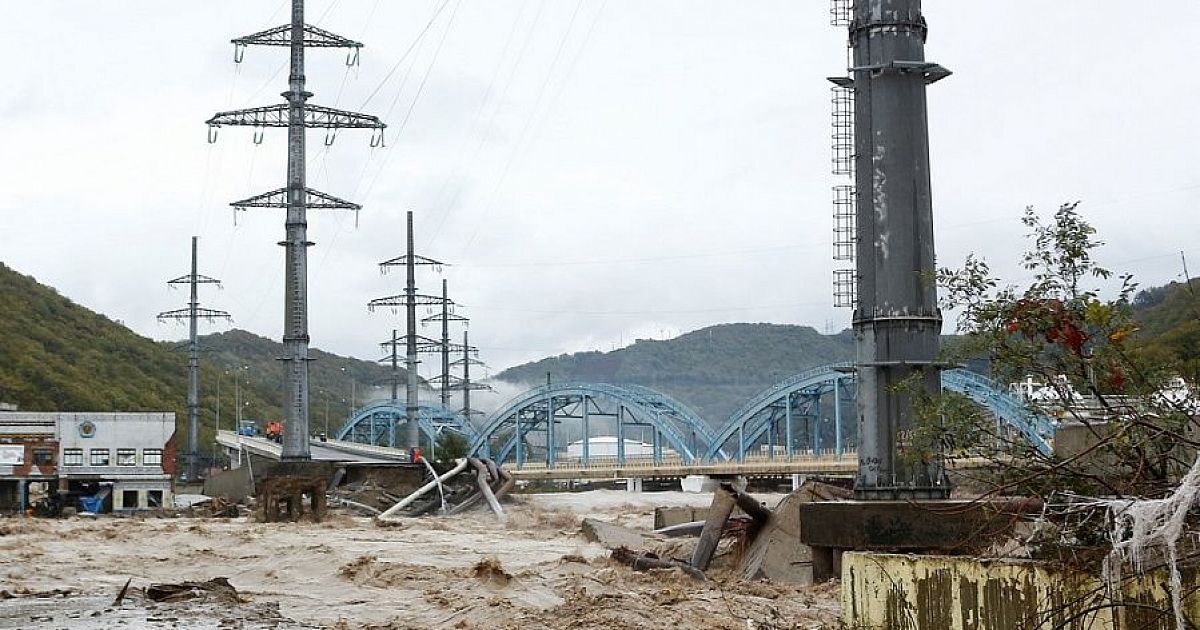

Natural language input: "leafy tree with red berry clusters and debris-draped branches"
[936,203,1200,628]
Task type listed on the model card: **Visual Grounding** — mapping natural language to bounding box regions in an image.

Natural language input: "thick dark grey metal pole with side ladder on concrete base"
[830,0,949,499]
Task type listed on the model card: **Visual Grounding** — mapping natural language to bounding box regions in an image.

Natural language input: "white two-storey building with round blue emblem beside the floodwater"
[0,412,175,511]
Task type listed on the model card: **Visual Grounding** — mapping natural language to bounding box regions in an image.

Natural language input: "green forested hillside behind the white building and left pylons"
[0,264,403,451]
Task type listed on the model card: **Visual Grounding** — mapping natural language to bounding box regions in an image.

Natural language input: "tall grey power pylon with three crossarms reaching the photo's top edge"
[208,0,385,461]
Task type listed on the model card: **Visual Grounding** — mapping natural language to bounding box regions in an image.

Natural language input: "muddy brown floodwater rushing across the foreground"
[0,491,838,630]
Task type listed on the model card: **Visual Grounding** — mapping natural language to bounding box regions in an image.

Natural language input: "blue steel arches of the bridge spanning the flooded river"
[336,364,1054,469]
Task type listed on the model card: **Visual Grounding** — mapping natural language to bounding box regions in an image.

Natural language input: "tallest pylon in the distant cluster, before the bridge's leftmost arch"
[367,211,445,455]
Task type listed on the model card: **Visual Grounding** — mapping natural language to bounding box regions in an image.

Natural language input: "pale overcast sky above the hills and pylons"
[0,0,1200,379]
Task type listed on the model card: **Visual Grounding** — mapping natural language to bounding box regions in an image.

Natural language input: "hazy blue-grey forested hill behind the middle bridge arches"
[496,324,854,425]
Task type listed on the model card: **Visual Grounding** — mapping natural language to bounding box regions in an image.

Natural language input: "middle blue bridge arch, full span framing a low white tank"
[468,383,713,468]
